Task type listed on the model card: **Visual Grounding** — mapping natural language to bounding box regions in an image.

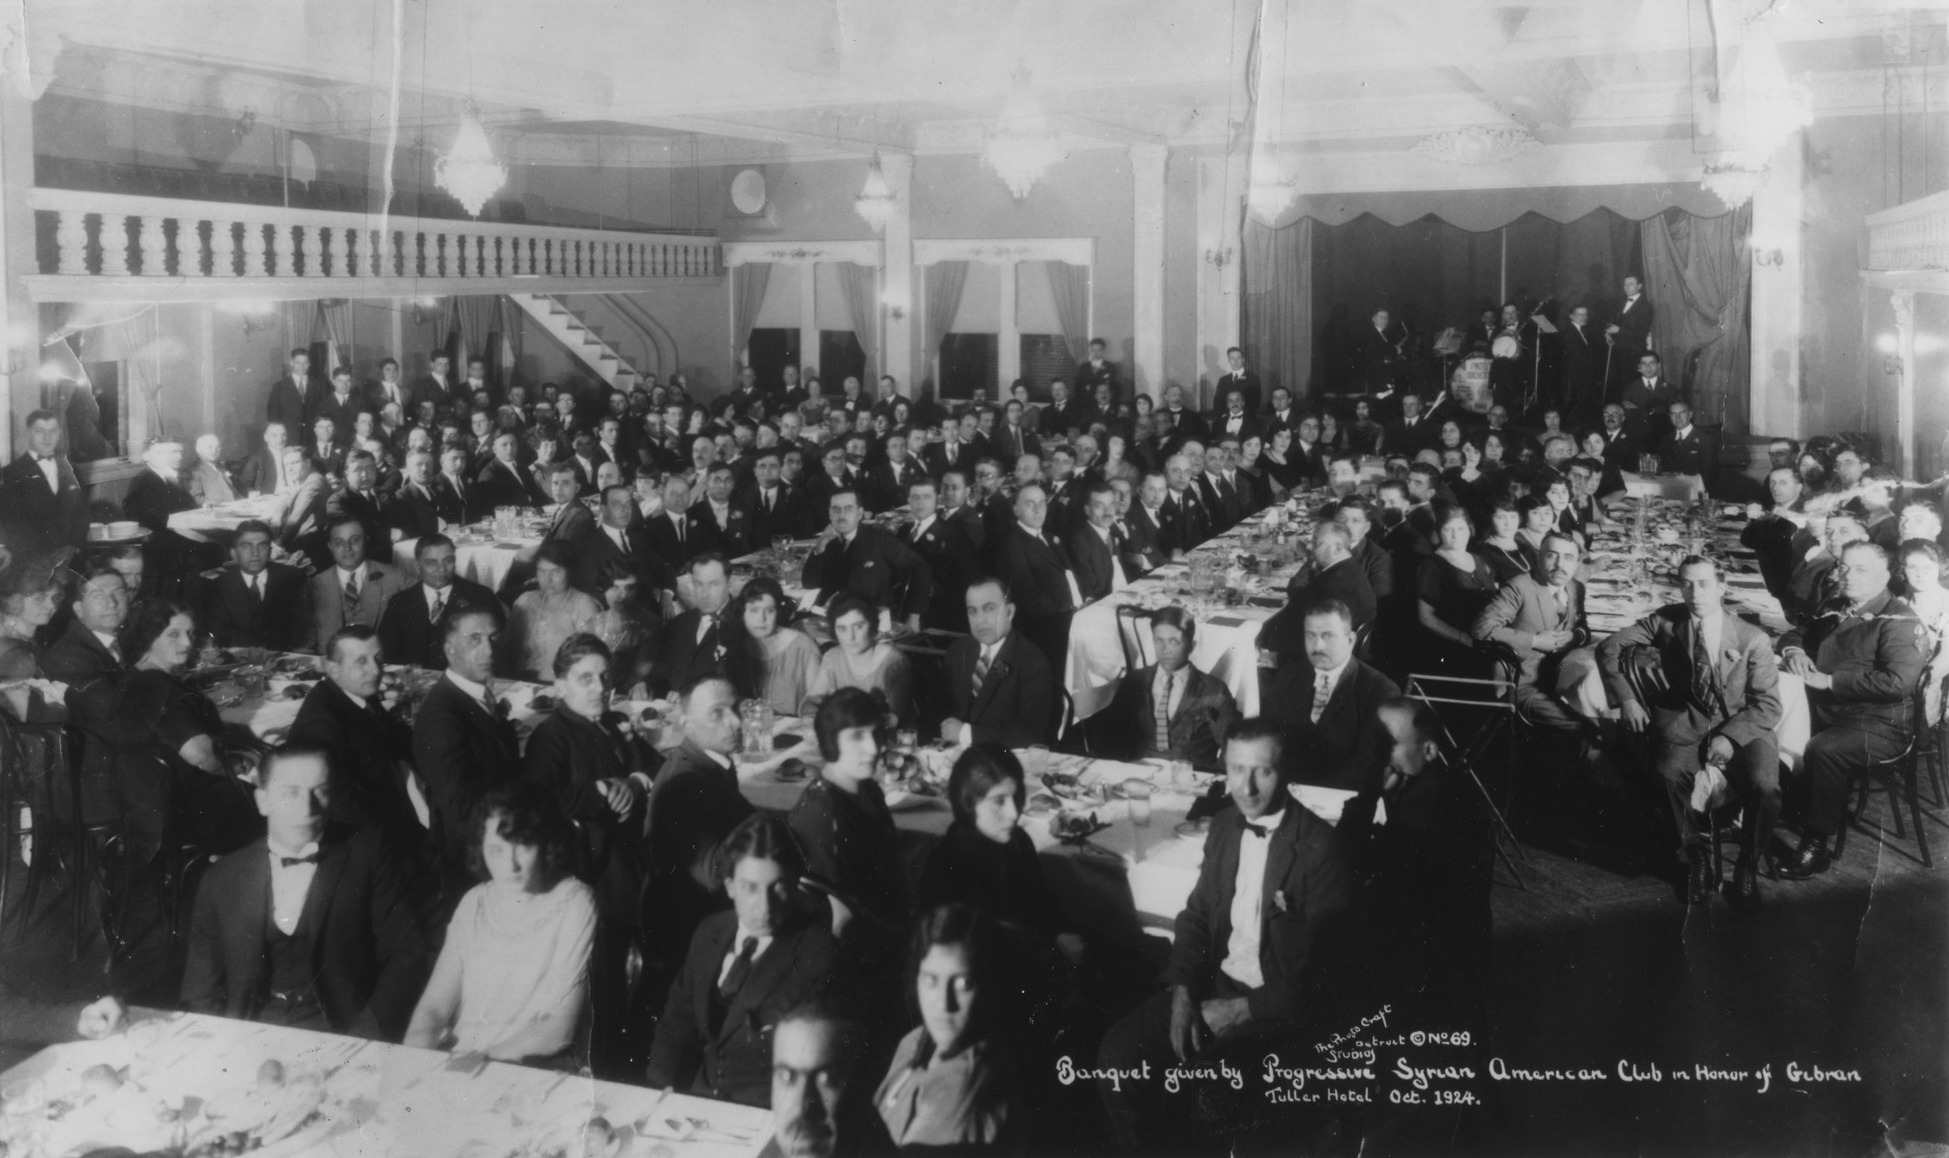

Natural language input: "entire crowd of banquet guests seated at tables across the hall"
[0,354,1949,1152]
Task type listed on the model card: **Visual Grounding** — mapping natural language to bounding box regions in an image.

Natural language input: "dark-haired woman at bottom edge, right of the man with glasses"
[873,905,1027,1154]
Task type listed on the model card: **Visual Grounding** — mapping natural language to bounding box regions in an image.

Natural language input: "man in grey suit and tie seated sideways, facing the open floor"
[1596,556,1779,908]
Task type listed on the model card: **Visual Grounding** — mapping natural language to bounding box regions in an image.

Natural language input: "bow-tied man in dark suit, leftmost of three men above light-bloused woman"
[290,626,431,857]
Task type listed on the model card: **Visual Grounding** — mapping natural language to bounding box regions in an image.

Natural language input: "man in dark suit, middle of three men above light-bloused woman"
[413,606,520,900]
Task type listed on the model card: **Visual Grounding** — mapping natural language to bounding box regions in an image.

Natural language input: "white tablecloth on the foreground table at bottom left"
[0,1012,772,1158]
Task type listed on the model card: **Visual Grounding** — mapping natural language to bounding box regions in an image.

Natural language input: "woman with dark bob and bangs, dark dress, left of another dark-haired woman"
[789,688,912,932]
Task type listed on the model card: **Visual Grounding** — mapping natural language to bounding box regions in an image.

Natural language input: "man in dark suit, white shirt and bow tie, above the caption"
[1097,719,1355,1152]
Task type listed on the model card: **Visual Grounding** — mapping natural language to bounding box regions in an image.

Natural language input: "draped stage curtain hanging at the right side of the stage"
[1639,205,1752,431]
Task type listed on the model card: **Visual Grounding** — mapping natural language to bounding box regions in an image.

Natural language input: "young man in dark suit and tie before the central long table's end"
[1091,606,1238,768]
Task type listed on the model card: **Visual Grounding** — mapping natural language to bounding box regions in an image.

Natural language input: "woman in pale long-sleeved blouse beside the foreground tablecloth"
[405,780,596,1066]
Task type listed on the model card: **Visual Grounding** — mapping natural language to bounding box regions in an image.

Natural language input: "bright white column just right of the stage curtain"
[1746,133,1807,439]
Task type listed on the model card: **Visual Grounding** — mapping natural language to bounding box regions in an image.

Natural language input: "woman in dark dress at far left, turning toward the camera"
[94,598,263,864]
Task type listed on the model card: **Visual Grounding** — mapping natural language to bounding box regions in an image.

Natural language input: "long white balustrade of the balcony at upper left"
[29,189,723,300]
